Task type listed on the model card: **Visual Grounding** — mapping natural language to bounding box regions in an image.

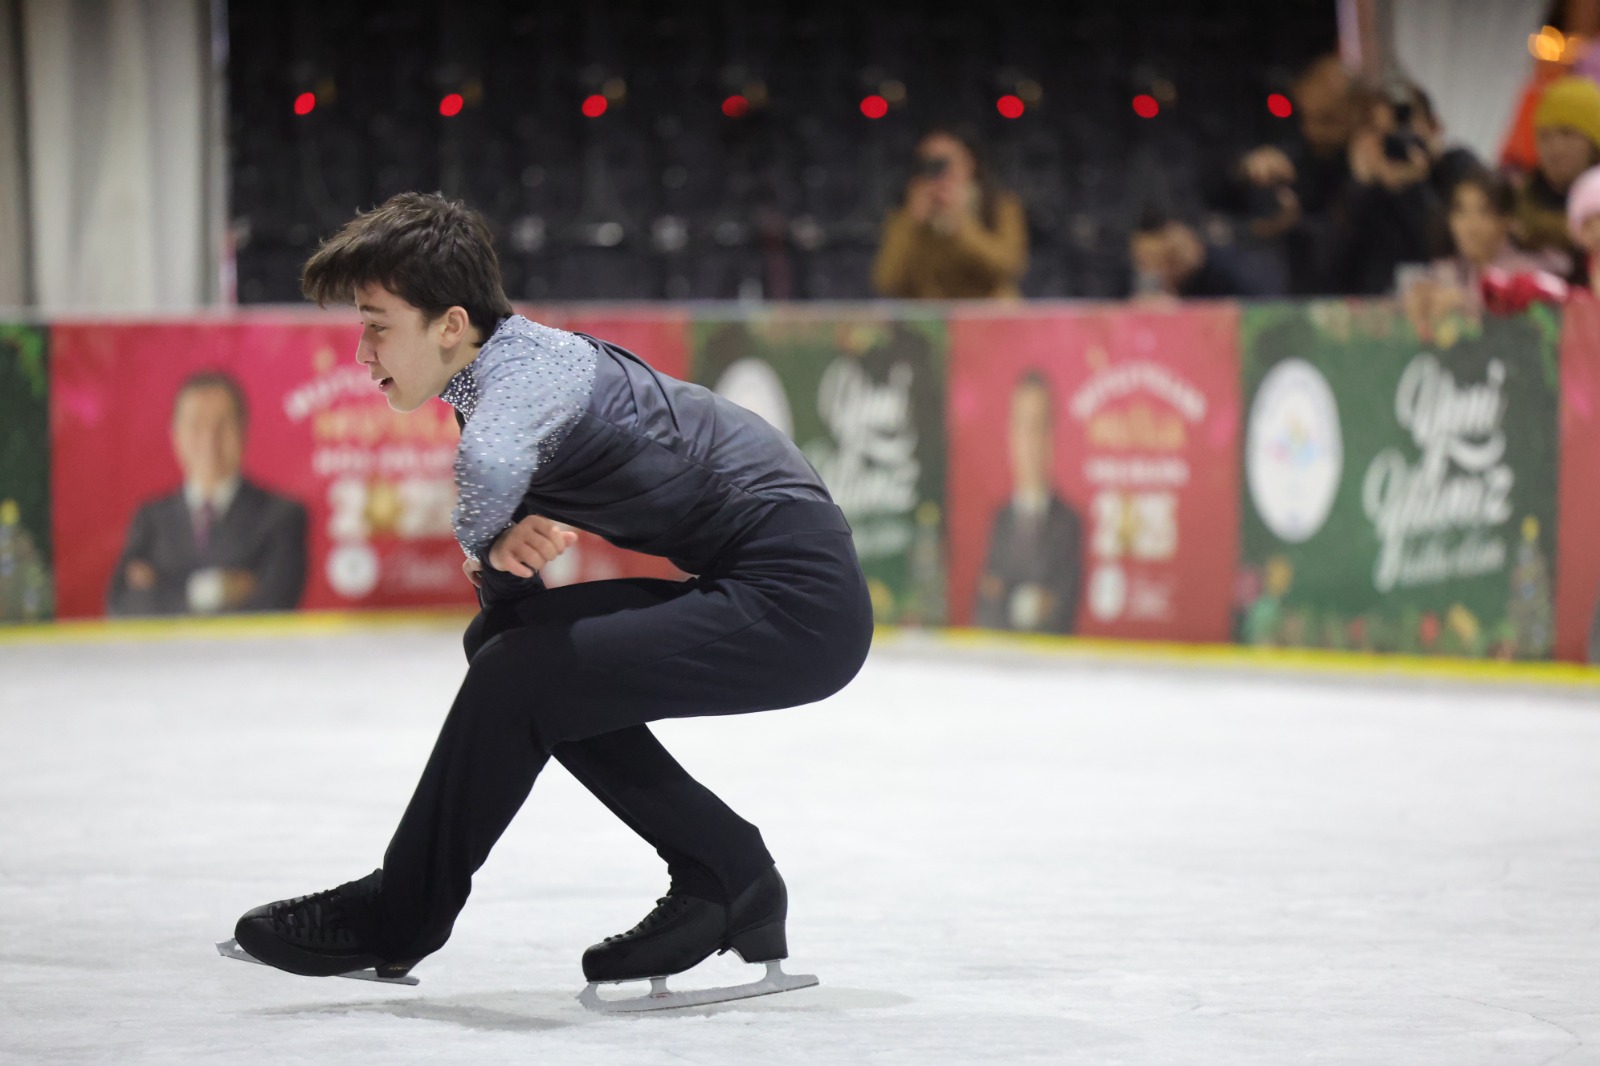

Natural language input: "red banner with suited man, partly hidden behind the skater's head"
[51,314,688,618]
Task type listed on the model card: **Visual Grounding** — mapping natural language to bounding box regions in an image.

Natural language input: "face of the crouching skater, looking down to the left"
[355,283,477,411]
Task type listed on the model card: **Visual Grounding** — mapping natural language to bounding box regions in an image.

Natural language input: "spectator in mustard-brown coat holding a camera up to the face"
[872,130,1027,299]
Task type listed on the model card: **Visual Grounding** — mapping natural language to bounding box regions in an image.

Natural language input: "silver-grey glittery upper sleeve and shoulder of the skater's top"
[453,323,595,560]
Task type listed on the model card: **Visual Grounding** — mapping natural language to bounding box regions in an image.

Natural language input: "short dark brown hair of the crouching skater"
[301,192,512,339]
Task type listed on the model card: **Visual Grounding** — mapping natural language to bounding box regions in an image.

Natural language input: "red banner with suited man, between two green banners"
[949,306,1238,642]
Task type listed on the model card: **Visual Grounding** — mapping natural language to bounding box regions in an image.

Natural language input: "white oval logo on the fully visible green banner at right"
[1245,359,1344,544]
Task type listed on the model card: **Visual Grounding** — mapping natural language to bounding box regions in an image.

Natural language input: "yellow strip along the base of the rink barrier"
[0,608,1600,693]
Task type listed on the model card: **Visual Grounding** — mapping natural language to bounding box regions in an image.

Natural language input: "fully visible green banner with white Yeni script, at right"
[1237,301,1560,659]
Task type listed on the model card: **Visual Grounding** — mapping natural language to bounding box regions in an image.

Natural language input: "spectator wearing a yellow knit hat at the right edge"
[1515,77,1600,272]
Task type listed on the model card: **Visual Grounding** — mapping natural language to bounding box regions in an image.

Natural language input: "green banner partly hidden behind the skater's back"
[691,311,947,624]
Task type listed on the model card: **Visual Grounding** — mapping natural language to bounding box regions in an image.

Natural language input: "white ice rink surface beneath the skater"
[0,629,1600,1066]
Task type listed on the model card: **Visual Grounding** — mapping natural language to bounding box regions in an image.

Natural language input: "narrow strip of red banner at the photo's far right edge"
[1555,290,1600,663]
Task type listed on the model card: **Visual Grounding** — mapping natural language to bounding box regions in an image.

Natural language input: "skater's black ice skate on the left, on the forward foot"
[216,871,418,984]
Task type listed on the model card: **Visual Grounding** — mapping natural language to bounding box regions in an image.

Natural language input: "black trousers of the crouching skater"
[373,503,872,960]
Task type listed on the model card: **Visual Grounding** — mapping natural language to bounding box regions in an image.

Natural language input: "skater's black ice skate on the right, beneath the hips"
[578,868,818,1012]
